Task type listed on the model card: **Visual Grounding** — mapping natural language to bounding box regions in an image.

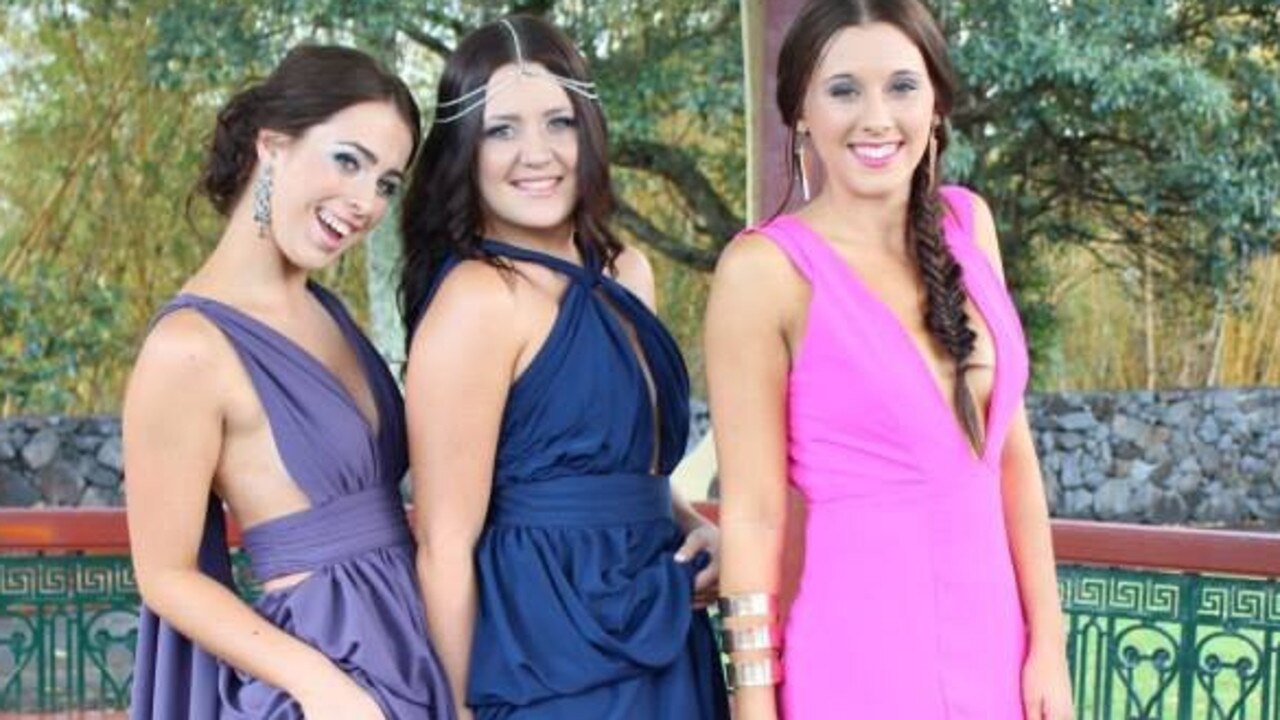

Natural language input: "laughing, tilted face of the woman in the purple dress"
[257,102,413,270]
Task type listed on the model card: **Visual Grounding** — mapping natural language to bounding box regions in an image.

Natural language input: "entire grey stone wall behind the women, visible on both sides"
[0,388,1280,529]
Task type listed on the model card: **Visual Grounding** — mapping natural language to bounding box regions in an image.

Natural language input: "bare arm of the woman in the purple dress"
[123,313,381,717]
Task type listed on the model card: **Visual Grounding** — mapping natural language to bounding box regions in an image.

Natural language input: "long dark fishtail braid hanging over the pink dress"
[908,167,984,452]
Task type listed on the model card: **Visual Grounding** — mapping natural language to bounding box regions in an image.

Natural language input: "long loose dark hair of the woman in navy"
[399,15,622,343]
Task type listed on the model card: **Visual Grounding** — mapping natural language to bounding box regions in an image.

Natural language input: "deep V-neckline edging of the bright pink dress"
[788,215,1004,462]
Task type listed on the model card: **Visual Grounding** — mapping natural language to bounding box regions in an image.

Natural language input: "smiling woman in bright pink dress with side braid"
[705,0,1071,720]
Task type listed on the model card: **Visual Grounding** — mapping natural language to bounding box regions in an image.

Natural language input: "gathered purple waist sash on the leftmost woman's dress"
[243,487,412,582]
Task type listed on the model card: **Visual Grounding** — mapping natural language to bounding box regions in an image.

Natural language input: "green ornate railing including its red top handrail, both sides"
[0,514,1280,720]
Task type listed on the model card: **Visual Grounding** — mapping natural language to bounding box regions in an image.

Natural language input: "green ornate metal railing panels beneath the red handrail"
[0,555,1280,720]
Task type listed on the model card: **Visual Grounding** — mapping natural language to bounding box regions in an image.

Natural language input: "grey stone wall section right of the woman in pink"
[1028,388,1280,528]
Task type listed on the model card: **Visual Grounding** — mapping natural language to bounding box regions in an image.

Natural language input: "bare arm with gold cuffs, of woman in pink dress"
[704,236,803,720]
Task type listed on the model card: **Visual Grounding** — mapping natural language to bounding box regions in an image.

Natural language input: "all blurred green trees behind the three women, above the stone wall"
[0,0,1280,414]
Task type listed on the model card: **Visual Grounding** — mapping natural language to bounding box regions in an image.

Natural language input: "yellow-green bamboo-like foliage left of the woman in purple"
[0,0,364,414]
